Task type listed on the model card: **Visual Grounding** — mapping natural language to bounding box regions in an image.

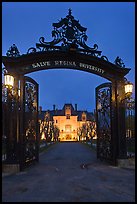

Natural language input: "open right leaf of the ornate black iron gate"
[96,83,116,164]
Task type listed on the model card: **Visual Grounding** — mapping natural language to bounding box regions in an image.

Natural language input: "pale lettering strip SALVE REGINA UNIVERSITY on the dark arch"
[27,61,104,74]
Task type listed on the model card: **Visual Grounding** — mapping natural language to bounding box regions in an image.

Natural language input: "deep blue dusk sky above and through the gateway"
[2,2,135,111]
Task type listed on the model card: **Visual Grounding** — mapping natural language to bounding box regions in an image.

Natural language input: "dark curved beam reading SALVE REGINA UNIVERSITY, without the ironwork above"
[2,50,130,81]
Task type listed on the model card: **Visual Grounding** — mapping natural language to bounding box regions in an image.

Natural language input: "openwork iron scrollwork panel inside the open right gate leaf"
[97,83,112,160]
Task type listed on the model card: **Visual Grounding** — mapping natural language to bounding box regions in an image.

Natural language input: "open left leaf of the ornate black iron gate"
[23,76,39,167]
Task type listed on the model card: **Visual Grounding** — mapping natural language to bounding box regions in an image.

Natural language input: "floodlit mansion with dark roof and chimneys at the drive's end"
[39,104,96,141]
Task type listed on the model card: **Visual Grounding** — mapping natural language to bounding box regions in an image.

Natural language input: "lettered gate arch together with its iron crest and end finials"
[2,9,130,80]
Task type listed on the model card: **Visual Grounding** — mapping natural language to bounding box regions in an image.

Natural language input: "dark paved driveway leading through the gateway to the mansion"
[2,142,135,202]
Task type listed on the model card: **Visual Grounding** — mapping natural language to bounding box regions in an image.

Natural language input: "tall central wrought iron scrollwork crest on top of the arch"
[27,9,108,61]
